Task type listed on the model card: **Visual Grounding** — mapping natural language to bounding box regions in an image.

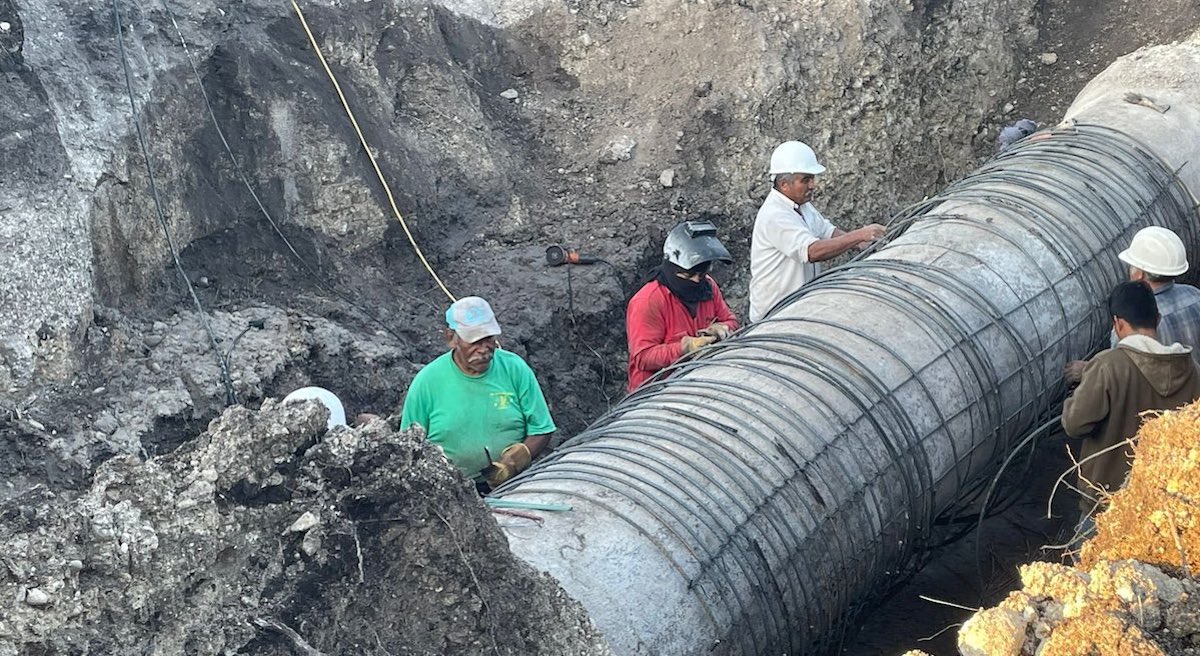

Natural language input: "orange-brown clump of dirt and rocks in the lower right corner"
[908,403,1200,656]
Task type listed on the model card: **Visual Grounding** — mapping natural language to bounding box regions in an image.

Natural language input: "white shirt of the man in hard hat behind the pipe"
[750,189,834,321]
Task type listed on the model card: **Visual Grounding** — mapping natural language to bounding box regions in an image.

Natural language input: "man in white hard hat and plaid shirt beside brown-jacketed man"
[1064,225,1200,383]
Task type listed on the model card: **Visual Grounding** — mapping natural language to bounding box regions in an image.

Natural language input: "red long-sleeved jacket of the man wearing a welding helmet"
[625,278,738,392]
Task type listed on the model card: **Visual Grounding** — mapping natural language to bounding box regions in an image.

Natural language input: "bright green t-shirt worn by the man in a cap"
[401,349,556,479]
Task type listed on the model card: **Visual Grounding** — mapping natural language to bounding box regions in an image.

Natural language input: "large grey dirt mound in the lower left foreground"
[0,402,608,656]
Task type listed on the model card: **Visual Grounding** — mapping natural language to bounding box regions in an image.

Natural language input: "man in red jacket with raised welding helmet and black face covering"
[625,221,738,392]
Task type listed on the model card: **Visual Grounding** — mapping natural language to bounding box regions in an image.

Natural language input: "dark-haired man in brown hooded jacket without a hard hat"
[1062,282,1200,519]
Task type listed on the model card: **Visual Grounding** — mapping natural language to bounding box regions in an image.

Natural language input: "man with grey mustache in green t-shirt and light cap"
[401,296,556,488]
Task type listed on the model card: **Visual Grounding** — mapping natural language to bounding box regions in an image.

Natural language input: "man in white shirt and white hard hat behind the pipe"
[750,142,884,321]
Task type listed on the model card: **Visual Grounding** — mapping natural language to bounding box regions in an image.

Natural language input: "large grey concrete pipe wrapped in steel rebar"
[498,37,1200,655]
